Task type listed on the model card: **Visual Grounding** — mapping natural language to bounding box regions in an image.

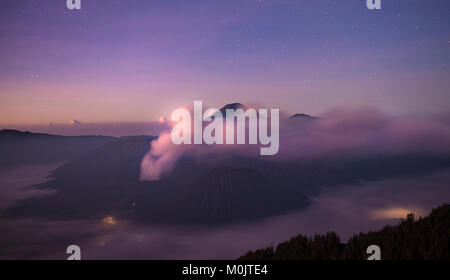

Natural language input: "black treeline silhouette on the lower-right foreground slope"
[239,204,450,260]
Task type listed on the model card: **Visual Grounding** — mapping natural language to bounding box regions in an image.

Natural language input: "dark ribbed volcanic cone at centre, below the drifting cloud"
[181,167,289,222]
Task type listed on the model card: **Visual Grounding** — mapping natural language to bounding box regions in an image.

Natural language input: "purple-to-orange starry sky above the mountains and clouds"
[0,0,450,125]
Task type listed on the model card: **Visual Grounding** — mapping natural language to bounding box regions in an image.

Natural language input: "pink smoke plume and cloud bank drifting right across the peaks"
[141,107,450,180]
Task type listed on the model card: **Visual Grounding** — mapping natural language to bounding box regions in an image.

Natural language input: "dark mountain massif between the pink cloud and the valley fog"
[0,117,450,224]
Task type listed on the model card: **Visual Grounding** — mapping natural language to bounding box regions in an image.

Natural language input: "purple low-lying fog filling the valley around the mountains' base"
[0,163,450,259]
